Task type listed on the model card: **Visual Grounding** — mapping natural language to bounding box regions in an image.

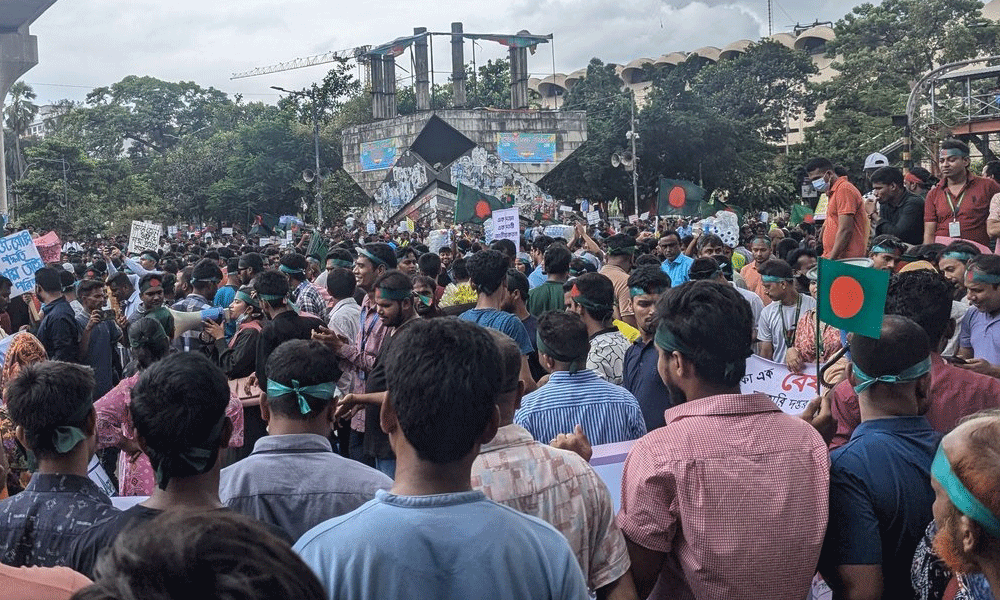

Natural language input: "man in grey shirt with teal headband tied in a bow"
[219,340,392,540]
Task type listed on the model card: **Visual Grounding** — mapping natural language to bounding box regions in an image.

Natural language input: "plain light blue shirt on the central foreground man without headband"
[294,490,589,600]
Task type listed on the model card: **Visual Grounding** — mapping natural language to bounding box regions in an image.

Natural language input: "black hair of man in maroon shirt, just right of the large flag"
[885,269,955,349]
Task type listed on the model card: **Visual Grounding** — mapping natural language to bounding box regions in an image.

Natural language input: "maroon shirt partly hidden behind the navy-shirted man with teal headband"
[830,354,1000,449]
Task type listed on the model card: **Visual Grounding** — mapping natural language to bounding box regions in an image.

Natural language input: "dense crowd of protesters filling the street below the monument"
[0,146,1000,600]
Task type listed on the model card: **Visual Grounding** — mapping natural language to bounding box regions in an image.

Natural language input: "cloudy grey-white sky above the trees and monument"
[15,0,859,103]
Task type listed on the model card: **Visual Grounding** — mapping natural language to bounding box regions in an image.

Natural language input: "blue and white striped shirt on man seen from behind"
[514,370,646,446]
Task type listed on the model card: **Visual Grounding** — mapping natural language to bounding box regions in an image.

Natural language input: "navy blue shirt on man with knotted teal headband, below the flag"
[820,417,941,598]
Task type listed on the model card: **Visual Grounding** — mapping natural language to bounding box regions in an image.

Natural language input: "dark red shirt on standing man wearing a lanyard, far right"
[924,173,1000,246]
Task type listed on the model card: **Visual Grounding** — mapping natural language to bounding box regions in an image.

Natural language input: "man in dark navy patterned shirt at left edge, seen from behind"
[0,361,118,567]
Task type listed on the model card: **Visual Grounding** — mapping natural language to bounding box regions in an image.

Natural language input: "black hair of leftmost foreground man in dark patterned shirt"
[5,361,94,456]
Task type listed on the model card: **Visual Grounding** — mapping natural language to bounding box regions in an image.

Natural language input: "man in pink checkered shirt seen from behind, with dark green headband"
[618,281,829,599]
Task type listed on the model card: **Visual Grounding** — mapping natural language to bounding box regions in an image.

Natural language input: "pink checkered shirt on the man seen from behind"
[618,394,830,600]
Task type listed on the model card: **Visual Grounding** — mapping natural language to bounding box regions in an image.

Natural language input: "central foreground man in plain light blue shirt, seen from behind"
[295,318,588,600]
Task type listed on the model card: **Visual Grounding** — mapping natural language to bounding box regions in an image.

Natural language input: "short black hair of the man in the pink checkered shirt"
[656,280,752,387]
